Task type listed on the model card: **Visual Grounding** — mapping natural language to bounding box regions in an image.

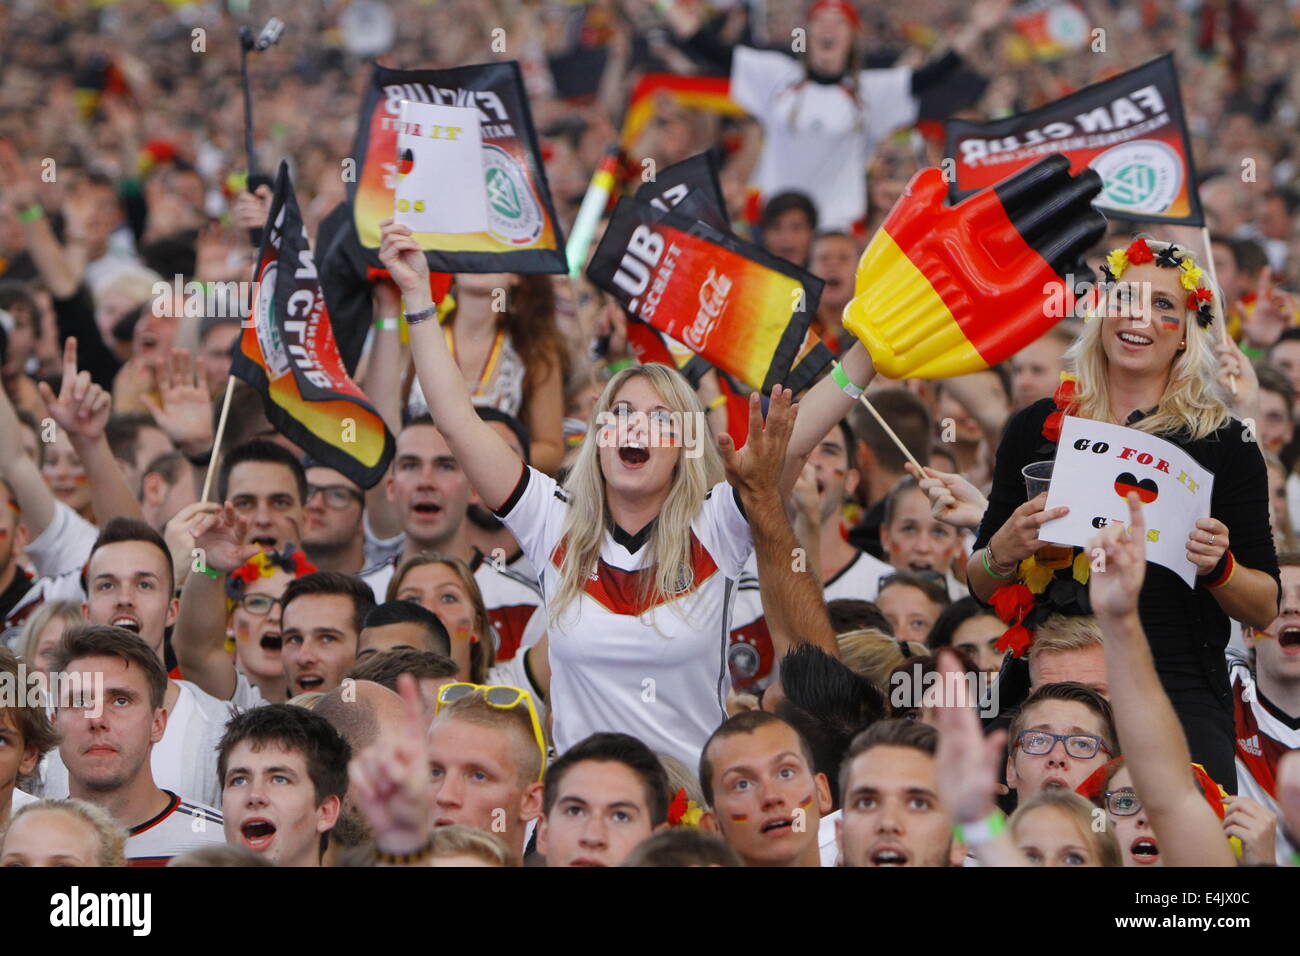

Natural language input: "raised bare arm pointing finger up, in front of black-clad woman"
[1088,493,1236,866]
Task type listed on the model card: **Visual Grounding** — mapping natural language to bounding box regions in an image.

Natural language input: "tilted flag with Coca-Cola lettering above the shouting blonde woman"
[586,198,823,393]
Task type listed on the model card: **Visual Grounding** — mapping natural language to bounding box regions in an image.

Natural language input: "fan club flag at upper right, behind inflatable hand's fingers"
[945,55,1205,226]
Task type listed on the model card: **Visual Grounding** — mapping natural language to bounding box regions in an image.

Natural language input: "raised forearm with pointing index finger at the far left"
[36,338,142,523]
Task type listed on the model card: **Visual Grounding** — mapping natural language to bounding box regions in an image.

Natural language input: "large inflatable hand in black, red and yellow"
[844,155,1106,378]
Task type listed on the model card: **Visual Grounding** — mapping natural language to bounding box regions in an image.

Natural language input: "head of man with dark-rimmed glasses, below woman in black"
[1006,682,1118,804]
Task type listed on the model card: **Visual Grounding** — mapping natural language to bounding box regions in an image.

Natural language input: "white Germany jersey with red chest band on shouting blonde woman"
[498,468,753,766]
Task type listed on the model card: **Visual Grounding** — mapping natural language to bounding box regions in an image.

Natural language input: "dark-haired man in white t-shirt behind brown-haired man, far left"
[44,518,230,804]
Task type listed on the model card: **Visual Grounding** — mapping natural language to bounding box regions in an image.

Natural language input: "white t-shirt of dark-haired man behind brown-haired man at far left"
[44,680,233,805]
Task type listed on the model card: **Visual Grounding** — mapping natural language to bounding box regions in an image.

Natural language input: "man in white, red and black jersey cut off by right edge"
[1229,554,1300,861]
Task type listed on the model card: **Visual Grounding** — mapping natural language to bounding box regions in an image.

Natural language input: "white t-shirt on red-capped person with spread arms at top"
[731,47,918,229]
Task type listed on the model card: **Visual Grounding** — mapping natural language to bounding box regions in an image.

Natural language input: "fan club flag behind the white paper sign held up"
[348,61,566,273]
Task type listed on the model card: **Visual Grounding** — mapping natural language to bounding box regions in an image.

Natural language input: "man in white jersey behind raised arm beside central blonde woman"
[727,420,893,691]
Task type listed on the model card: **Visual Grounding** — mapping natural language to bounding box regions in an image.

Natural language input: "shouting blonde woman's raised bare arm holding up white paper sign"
[380,220,524,509]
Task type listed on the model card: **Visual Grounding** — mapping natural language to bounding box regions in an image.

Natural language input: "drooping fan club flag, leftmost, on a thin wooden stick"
[231,163,394,488]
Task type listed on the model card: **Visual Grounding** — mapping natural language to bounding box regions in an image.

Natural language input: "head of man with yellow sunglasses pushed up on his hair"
[426,683,546,857]
